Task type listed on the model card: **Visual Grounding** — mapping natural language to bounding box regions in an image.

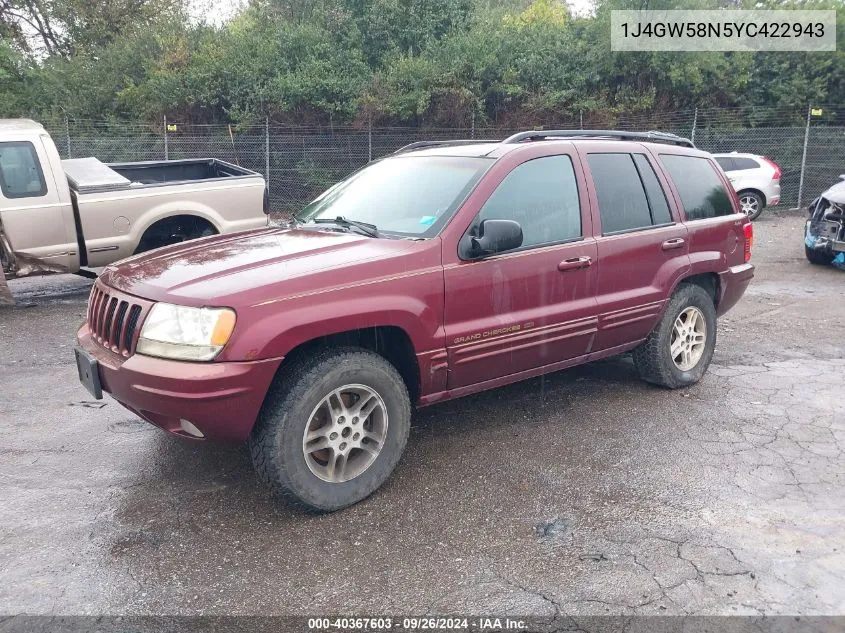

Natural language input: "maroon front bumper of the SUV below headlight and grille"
[77,324,282,443]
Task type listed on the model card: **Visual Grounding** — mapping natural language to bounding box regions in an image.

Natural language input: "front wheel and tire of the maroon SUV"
[249,347,411,512]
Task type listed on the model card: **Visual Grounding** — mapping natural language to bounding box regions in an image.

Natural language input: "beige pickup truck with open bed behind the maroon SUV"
[0,119,269,301]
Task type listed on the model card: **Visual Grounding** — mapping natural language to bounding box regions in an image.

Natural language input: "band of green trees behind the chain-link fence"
[0,0,845,131]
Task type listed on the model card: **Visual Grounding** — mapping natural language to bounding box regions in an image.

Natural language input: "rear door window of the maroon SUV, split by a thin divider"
[587,154,672,235]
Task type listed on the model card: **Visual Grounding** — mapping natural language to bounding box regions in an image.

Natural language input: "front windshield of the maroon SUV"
[297,156,493,237]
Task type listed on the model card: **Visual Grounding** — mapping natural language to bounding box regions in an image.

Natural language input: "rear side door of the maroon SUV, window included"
[585,151,689,350]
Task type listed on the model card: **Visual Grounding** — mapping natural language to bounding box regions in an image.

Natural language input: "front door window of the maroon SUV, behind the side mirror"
[475,156,581,248]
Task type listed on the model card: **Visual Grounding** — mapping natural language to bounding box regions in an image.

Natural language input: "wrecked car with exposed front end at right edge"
[804,174,845,266]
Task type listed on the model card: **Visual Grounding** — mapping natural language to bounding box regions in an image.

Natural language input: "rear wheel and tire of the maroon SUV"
[634,284,716,389]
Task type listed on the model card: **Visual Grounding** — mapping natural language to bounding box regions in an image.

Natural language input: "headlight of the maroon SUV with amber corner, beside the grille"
[137,303,235,360]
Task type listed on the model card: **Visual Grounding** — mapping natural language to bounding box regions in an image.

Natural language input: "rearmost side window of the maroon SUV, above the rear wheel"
[660,154,734,220]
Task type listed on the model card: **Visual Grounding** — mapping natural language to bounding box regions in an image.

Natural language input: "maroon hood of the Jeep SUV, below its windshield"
[100,228,415,307]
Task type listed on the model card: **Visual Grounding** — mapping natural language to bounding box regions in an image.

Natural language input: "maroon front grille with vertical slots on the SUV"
[88,282,147,357]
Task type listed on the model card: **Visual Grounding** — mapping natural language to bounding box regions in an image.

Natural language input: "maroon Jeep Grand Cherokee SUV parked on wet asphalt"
[76,131,754,510]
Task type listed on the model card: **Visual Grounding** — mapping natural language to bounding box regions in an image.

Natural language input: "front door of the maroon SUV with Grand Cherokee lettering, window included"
[444,154,597,389]
